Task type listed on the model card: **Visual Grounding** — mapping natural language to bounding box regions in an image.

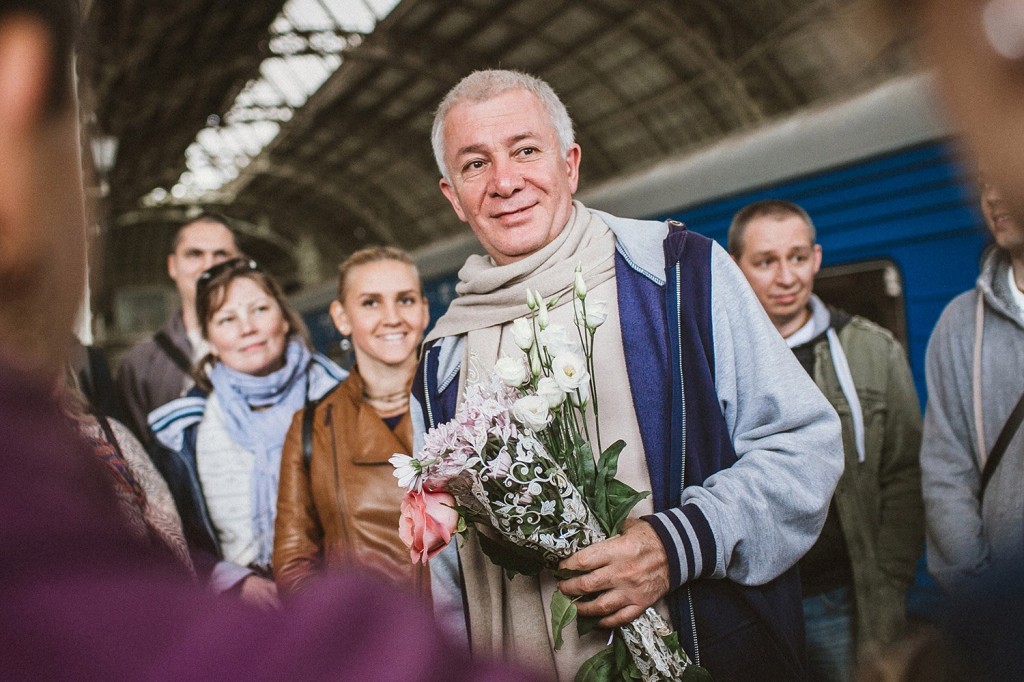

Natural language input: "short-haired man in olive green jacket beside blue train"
[729,200,924,680]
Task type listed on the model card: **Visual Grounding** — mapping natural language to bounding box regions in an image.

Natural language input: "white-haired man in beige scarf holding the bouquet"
[411,71,843,680]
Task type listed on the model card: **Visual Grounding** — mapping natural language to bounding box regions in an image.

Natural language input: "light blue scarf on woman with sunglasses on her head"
[204,339,312,568]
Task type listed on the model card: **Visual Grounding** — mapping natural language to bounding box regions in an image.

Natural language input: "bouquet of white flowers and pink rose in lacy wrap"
[391,266,709,681]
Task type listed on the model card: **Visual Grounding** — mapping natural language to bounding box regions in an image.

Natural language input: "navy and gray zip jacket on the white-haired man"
[414,211,843,680]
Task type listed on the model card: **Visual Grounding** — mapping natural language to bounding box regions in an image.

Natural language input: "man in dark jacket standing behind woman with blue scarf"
[117,213,240,444]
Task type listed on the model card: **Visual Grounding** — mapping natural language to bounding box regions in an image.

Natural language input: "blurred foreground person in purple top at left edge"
[0,0,529,682]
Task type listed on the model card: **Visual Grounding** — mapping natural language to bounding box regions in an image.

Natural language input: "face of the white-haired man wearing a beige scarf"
[440,89,580,265]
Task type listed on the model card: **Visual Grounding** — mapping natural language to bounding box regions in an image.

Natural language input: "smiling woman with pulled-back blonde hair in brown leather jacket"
[273,247,429,596]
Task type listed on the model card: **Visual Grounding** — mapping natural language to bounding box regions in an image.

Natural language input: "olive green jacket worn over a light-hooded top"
[795,296,925,655]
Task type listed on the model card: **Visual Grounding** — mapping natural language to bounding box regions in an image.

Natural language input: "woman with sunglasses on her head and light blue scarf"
[148,258,345,606]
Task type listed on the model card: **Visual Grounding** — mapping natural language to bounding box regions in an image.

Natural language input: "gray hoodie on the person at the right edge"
[921,250,1024,590]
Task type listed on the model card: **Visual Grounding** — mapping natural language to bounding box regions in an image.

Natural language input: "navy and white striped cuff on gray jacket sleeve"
[642,505,718,590]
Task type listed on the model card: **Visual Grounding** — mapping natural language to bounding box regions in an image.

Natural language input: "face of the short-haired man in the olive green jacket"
[736,215,821,337]
